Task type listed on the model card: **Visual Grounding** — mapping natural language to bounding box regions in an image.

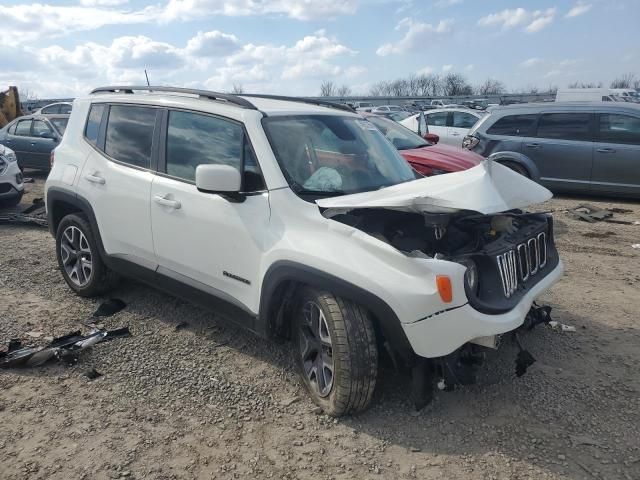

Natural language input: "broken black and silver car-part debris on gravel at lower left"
[0,327,131,368]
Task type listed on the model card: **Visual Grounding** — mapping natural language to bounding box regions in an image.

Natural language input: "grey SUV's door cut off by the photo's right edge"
[591,113,640,196]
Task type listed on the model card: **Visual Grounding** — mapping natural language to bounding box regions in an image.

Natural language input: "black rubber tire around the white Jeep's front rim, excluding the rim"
[294,287,378,417]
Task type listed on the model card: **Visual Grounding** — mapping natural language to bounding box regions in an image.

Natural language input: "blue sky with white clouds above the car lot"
[0,0,640,98]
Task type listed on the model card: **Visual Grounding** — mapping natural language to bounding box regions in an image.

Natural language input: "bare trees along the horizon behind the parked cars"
[320,72,640,97]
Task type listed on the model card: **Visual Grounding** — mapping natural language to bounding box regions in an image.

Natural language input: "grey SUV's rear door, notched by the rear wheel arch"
[522,111,594,192]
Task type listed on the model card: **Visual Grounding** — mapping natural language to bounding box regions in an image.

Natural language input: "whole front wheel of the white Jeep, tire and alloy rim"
[295,287,378,416]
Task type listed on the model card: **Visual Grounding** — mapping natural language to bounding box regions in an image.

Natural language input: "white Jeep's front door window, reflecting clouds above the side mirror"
[167,111,244,182]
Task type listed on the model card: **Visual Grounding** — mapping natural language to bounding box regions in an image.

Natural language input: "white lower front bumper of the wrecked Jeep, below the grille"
[402,261,564,358]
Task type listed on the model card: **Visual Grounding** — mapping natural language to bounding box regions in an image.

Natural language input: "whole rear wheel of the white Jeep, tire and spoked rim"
[56,214,118,297]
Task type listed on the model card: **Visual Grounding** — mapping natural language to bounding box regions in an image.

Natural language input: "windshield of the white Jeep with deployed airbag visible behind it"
[262,115,416,195]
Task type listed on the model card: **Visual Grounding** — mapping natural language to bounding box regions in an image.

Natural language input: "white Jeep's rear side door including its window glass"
[78,104,162,270]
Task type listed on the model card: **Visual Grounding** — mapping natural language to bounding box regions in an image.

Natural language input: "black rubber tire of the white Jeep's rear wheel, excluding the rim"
[56,213,118,297]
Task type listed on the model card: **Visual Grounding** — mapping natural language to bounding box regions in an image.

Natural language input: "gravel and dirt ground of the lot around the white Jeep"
[0,173,640,480]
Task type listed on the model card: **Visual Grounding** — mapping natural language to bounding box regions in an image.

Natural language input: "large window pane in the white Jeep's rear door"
[104,105,156,168]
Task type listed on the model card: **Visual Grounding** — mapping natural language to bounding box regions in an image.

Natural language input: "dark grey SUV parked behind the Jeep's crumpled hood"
[463,102,640,197]
